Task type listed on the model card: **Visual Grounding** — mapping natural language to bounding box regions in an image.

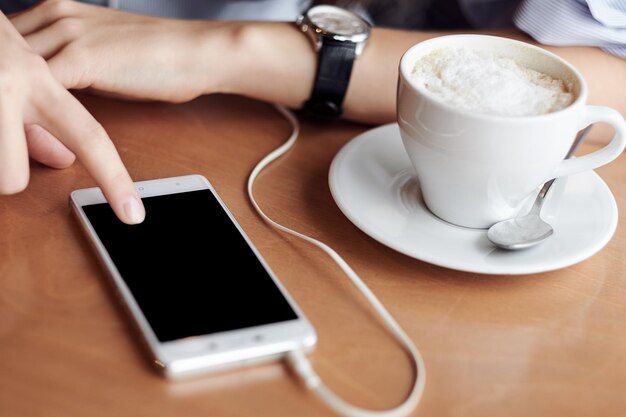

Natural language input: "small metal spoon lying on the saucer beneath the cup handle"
[487,125,591,250]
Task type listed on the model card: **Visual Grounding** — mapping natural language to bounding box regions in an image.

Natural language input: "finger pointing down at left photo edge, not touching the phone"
[0,91,29,194]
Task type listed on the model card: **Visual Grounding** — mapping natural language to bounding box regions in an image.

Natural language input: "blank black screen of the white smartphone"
[83,190,297,342]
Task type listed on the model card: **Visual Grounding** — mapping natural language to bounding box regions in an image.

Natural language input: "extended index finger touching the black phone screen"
[39,84,145,224]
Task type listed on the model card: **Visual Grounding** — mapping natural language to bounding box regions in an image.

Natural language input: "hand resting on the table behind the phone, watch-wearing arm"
[11,0,236,102]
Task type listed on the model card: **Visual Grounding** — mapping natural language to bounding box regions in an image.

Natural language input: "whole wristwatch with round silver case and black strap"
[296,5,371,119]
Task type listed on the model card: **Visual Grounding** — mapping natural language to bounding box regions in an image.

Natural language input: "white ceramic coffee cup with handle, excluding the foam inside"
[397,35,626,228]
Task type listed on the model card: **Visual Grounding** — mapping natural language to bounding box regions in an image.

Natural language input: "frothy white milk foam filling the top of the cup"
[412,48,575,116]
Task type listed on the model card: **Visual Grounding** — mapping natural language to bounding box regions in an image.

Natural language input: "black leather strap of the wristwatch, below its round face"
[304,39,356,119]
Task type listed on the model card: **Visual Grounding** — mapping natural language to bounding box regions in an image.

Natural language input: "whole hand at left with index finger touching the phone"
[0,13,145,223]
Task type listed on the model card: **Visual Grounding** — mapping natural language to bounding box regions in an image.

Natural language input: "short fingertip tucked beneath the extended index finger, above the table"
[24,124,76,169]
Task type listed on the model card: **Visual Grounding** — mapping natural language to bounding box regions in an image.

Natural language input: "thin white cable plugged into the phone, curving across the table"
[248,105,426,417]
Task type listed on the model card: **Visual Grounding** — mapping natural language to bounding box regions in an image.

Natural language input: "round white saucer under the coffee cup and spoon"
[329,124,617,274]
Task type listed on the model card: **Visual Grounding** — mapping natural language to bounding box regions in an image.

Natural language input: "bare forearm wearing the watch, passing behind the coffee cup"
[212,23,626,124]
